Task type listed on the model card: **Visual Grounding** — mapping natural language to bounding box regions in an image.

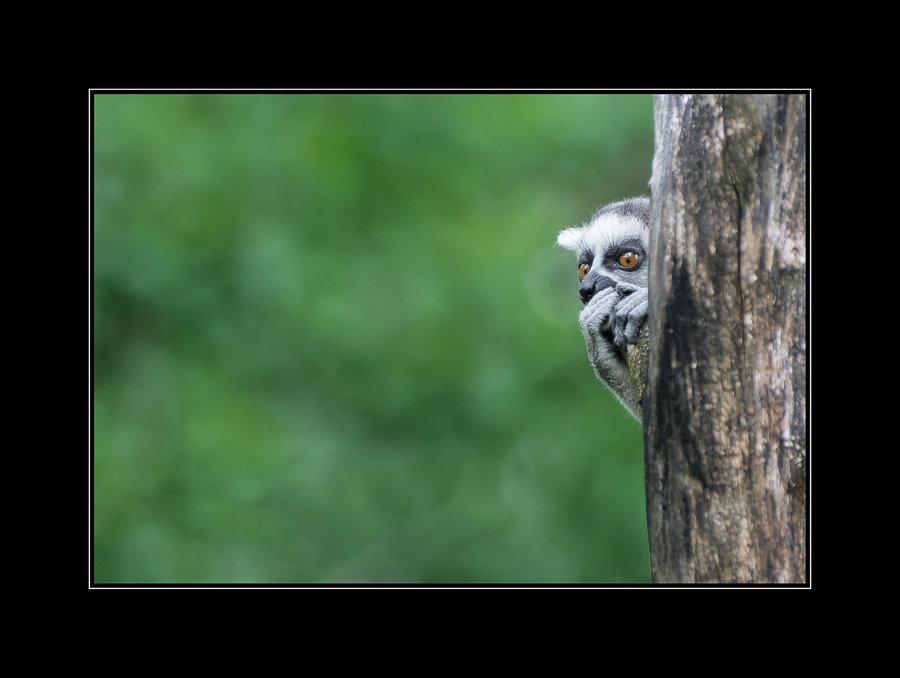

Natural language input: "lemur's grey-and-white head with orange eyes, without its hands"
[556,198,650,304]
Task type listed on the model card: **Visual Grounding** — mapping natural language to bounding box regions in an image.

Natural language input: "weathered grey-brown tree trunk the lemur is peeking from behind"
[644,94,807,583]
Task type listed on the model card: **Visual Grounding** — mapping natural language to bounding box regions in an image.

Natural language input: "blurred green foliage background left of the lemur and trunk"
[93,93,653,584]
